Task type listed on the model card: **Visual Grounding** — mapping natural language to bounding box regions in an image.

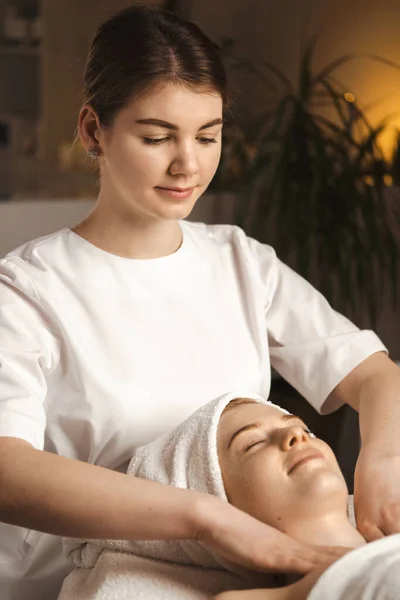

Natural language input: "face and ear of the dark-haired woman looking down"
[80,84,223,221]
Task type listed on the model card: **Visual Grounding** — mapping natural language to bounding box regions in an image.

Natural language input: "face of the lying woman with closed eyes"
[218,402,348,531]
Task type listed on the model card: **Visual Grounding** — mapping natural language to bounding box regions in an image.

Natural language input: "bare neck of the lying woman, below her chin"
[285,512,366,548]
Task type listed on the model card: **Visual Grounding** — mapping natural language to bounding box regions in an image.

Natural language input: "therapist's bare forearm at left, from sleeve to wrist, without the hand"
[0,438,207,539]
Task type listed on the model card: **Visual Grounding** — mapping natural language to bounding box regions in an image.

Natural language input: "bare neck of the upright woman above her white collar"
[73,199,182,259]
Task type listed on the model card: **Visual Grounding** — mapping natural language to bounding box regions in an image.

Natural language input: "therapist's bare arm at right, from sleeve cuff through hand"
[326,353,400,541]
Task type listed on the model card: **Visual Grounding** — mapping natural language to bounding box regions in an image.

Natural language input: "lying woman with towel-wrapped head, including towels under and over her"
[58,392,400,600]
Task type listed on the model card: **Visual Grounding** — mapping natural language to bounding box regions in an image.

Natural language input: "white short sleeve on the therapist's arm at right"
[244,238,387,413]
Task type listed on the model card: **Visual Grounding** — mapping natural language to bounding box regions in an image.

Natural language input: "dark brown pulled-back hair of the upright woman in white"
[84,6,229,126]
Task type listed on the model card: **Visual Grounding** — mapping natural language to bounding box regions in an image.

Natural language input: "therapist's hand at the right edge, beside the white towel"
[354,446,400,542]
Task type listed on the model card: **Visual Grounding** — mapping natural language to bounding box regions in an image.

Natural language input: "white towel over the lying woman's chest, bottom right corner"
[308,534,400,600]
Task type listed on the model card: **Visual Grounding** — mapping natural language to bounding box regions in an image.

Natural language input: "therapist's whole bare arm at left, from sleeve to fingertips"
[0,437,344,573]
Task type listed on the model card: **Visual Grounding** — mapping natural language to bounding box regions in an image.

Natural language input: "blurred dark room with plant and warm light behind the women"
[0,0,400,482]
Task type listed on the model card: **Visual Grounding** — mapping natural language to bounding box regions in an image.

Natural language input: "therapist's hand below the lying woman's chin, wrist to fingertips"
[195,497,349,575]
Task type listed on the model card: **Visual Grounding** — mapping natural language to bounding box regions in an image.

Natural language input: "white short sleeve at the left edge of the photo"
[0,259,60,450]
